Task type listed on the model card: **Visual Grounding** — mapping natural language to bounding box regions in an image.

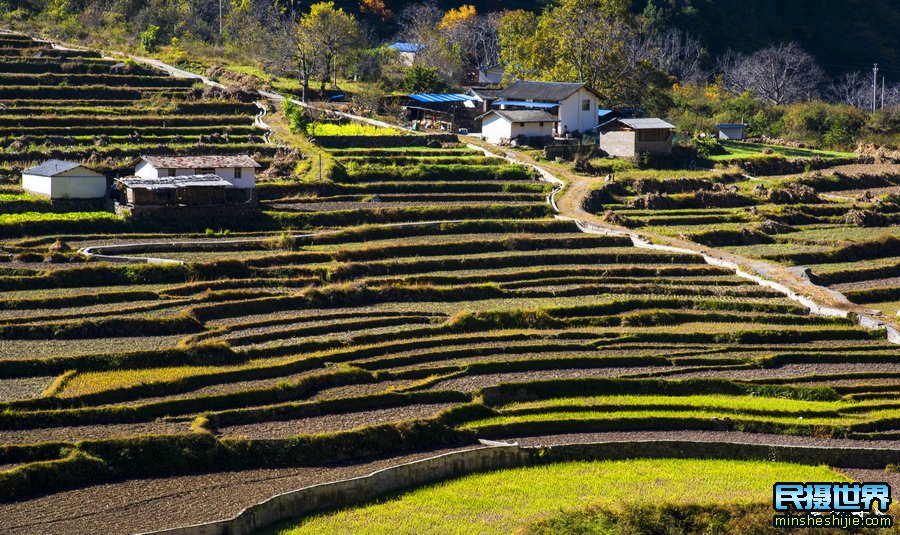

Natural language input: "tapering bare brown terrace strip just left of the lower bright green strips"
[219,403,458,439]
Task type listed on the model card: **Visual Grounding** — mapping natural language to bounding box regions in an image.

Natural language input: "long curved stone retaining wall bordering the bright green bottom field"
[142,440,900,535]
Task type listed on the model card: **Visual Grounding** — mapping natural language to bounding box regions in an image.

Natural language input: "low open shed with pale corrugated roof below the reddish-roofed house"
[116,174,232,207]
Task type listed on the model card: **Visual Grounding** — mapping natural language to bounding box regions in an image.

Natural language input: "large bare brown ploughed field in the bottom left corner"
[0,446,475,535]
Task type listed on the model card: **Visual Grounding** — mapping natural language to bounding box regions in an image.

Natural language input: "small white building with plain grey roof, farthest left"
[22,160,106,199]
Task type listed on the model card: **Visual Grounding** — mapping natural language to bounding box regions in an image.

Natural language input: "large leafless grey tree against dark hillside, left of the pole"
[720,43,824,105]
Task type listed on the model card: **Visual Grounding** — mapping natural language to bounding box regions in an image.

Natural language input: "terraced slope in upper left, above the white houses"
[0,33,275,180]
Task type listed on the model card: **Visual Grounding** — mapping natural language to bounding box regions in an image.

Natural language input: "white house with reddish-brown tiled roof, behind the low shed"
[134,154,260,189]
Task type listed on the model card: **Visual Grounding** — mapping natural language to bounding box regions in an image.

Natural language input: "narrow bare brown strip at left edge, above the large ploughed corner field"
[0,420,190,444]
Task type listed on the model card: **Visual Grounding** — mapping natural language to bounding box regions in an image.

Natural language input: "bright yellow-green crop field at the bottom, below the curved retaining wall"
[264,460,845,535]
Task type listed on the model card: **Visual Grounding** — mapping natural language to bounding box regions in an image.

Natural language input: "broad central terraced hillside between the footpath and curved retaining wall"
[0,124,900,533]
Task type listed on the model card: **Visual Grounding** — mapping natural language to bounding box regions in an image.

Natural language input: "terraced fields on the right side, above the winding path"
[590,164,900,322]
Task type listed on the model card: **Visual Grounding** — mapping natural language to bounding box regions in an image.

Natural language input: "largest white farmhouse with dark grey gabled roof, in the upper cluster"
[494,80,600,136]
